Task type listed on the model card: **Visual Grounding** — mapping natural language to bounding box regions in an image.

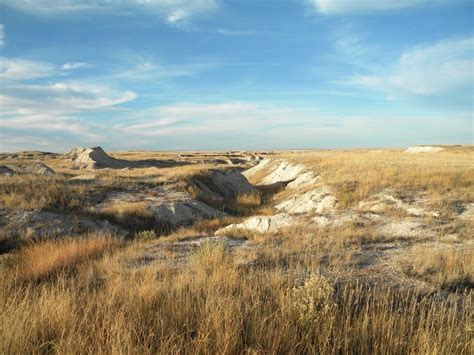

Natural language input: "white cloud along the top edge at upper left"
[0,0,219,27]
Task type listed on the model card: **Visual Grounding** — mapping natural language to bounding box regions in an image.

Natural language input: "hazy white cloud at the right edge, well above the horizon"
[354,37,474,96]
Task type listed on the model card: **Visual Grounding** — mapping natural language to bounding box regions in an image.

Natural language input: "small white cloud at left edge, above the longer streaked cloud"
[0,57,55,80]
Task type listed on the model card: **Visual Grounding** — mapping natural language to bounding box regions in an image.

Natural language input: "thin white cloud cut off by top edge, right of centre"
[309,0,427,15]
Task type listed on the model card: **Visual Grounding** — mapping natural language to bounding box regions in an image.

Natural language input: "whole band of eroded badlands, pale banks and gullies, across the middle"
[0,146,474,268]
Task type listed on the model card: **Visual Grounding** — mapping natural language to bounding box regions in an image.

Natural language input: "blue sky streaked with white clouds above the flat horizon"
[0,0,474,152]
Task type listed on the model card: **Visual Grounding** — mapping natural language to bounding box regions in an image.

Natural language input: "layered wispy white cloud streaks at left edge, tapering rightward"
[0,58,137,137]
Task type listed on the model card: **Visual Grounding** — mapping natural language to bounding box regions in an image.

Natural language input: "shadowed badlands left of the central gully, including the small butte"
[0,147,265,245]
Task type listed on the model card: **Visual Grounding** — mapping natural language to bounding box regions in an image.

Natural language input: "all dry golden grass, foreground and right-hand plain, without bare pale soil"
[0,148,474,354]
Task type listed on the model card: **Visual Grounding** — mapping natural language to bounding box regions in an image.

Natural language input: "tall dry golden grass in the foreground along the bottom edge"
[0,245,471,354]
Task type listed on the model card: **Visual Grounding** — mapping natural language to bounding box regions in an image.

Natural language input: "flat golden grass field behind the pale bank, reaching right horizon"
[282,147,474,215]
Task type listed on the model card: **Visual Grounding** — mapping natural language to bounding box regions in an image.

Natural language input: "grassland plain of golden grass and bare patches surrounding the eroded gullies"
[0,146,474,354]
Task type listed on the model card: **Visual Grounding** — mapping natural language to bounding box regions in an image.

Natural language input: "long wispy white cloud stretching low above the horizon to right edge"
[110,101,470,149]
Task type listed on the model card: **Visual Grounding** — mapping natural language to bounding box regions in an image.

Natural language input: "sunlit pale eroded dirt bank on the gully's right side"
[217,158,444,239]
